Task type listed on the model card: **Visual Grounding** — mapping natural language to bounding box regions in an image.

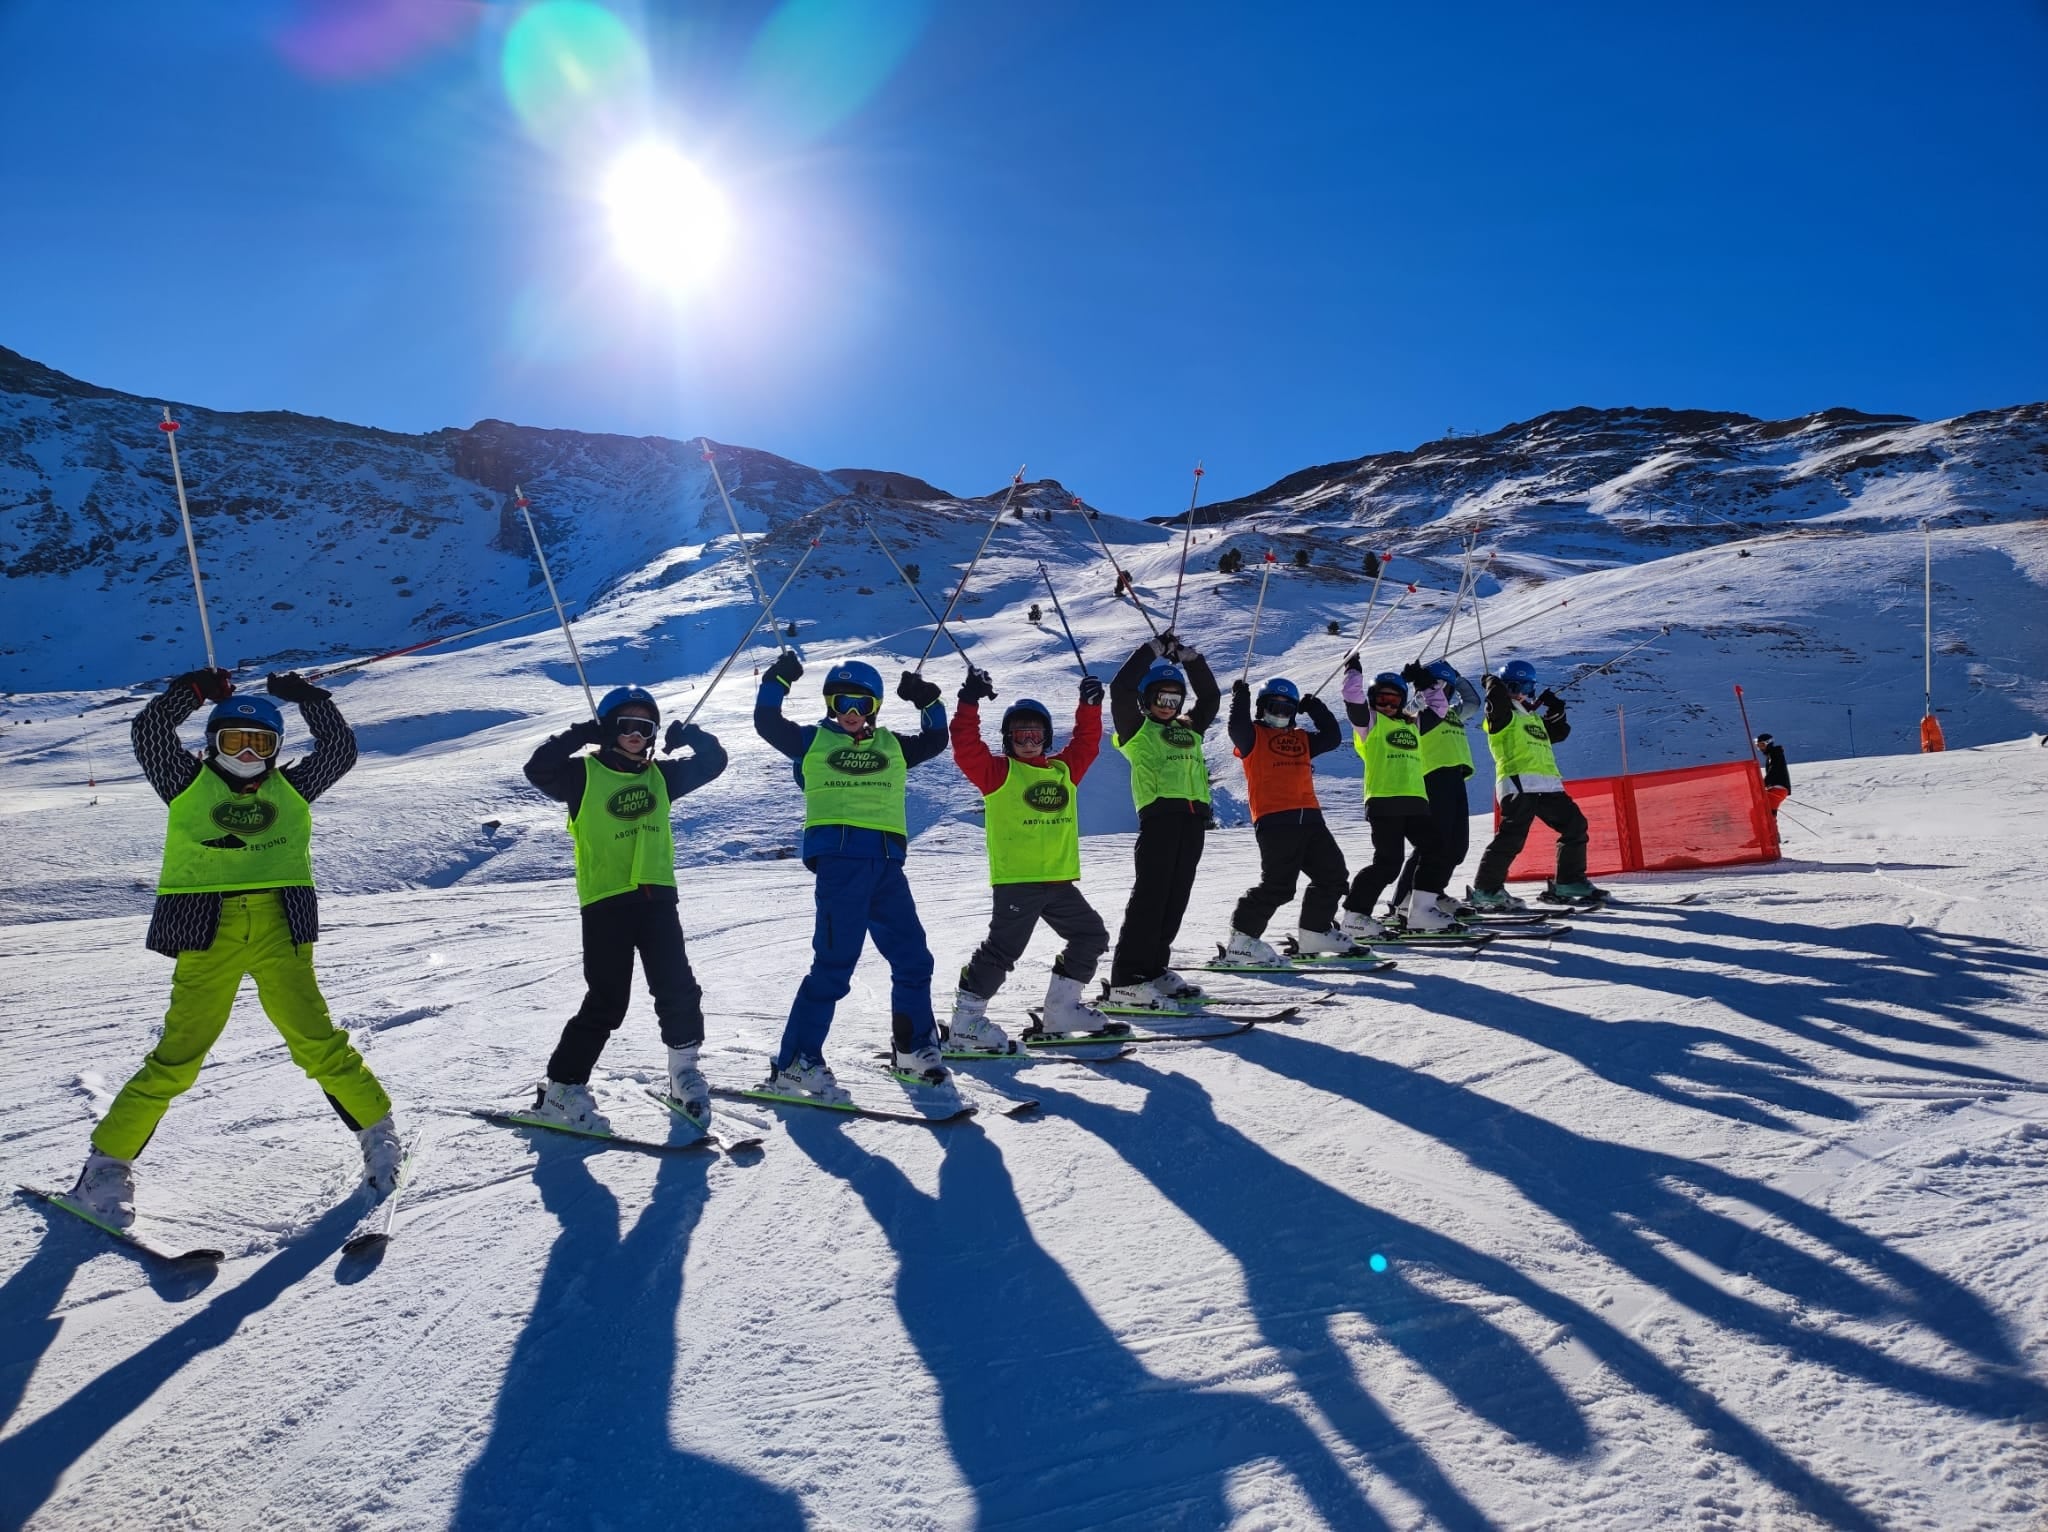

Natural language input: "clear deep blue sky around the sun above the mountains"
[0,0,2048,516]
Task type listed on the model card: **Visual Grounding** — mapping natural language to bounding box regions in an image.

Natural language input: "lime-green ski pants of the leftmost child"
[92,893,391,1159]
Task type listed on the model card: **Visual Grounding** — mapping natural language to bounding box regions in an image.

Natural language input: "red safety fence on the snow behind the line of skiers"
[1493,760,1778,883]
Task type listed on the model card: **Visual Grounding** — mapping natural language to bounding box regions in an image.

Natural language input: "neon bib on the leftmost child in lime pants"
[156,766,313,893]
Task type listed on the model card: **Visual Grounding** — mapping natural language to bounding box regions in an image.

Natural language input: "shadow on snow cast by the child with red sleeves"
[1038,1063,1587,1528]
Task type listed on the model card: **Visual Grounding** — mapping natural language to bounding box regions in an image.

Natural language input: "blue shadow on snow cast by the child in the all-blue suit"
[788,1116,1389,1530]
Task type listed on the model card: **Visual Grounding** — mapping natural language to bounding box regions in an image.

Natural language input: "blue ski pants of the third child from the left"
[774,856,938,1067]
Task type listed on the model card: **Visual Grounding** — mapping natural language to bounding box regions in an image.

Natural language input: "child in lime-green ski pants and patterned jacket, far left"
[72,670,403,1229]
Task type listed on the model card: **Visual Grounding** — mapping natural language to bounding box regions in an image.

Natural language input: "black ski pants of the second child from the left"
[547,887,705,1086]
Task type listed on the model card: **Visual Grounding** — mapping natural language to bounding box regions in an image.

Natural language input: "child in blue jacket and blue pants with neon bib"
[754,653,952,1102]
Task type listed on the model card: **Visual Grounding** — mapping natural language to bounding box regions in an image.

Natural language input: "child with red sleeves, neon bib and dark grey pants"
[948,670,1130,1053]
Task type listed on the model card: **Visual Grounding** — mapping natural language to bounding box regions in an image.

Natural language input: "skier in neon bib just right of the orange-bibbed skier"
[1341,653,1454,942]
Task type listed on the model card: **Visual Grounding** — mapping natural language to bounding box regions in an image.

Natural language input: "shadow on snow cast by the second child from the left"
[449,1143,803,1532]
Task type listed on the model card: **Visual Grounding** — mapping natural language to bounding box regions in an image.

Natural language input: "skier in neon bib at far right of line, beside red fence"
[1466,659,1606,911]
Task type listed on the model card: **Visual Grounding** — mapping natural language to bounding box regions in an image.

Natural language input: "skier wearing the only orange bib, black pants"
[1223,676,1352,963]
